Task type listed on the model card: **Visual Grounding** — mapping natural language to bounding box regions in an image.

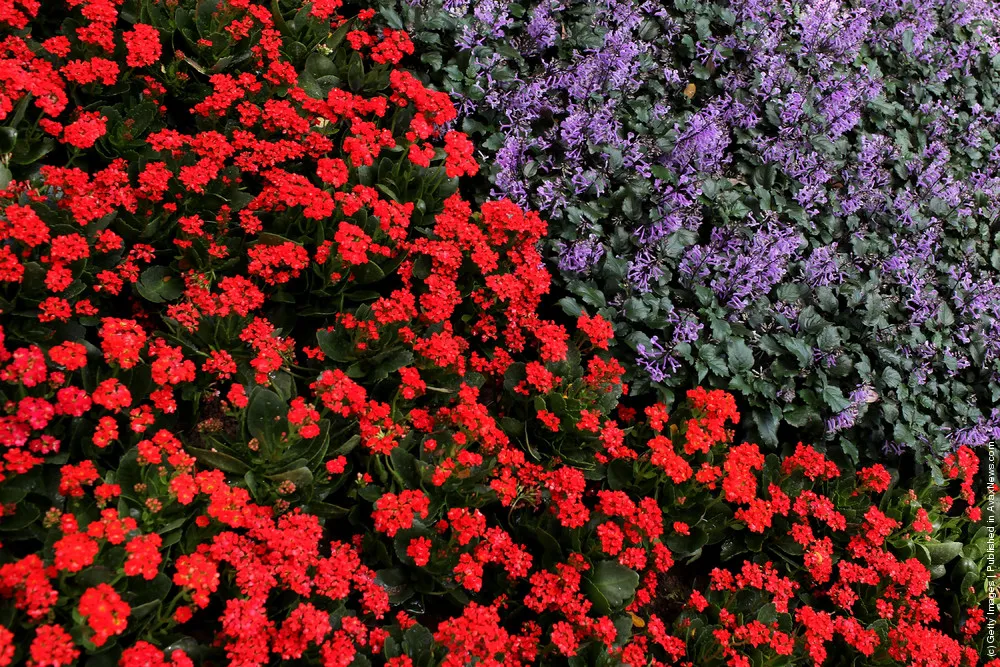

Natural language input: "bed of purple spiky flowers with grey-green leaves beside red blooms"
[370,0,1000,460]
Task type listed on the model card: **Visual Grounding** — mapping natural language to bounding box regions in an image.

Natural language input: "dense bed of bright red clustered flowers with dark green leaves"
[0,0,996,667]
